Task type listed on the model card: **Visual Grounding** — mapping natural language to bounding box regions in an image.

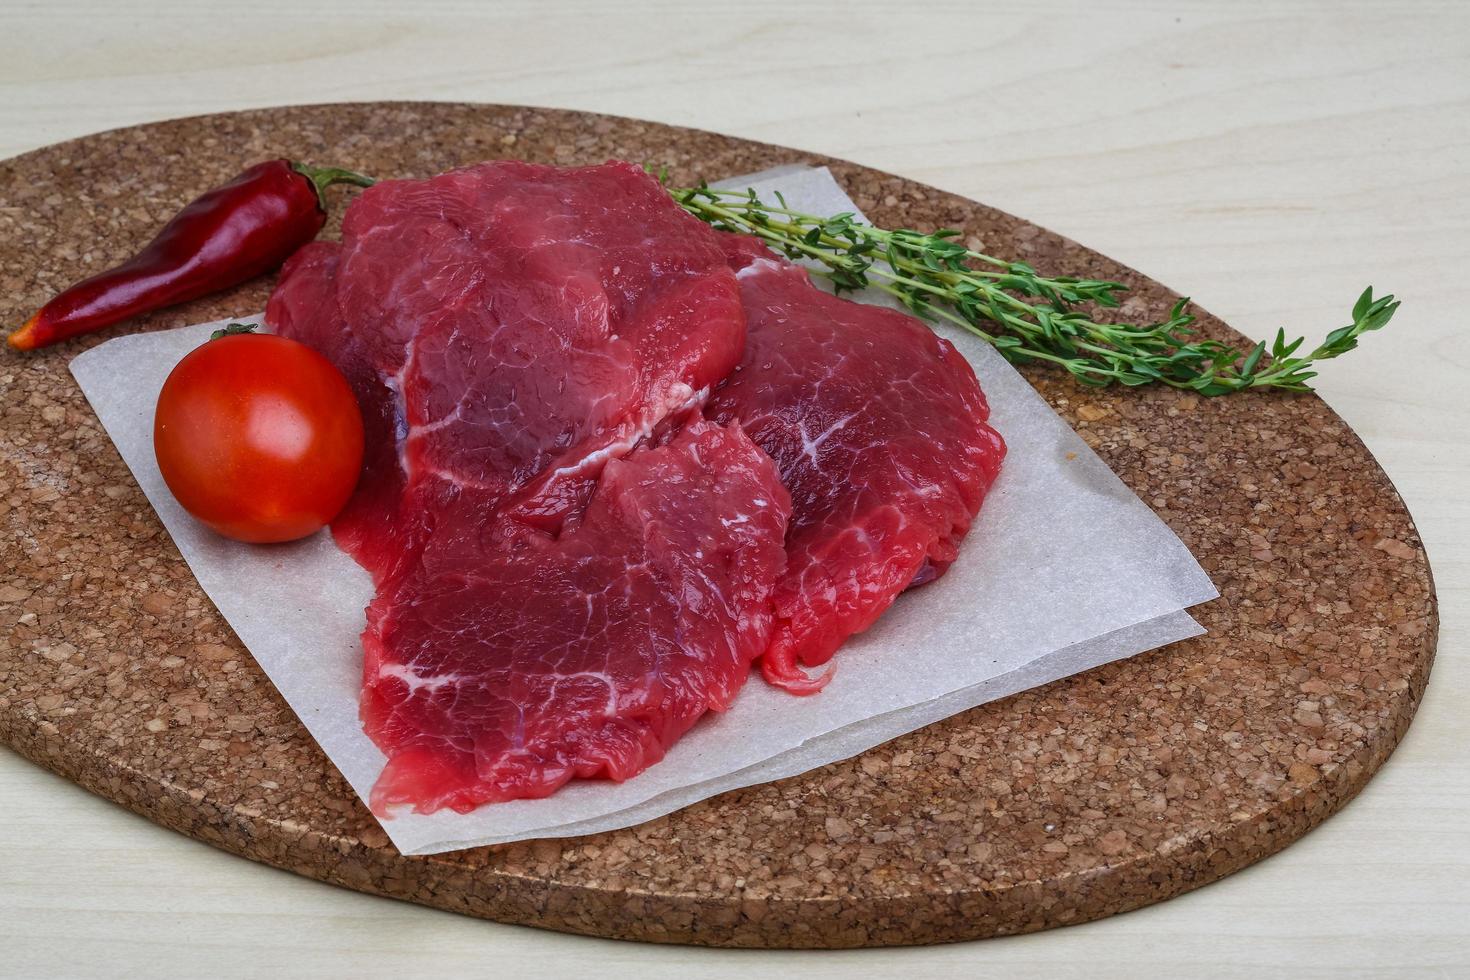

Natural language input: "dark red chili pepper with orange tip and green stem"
[6,160,372,351]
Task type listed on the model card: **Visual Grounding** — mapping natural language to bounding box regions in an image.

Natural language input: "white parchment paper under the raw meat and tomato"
[71,167,1217,854]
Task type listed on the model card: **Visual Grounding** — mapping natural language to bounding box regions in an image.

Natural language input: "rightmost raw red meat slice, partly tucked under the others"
[706,235,1005,693]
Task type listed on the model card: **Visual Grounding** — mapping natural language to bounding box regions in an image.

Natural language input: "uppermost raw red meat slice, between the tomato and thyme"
[338,162,744,527]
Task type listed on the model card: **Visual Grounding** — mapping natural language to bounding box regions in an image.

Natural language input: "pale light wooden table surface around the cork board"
[0,0,1470,980]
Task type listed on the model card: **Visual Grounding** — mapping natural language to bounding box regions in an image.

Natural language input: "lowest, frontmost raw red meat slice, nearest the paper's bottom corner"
[363,419,789,813]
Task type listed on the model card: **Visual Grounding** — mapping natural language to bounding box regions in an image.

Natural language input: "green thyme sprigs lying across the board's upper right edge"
[669,184,1398,395]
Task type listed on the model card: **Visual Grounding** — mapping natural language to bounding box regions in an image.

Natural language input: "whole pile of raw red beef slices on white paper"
[268,162,1004,814]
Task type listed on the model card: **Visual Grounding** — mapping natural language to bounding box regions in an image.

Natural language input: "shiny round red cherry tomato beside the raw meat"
[153,334,363,542]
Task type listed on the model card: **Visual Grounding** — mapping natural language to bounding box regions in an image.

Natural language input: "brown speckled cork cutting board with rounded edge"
[0,103,1438,946]
